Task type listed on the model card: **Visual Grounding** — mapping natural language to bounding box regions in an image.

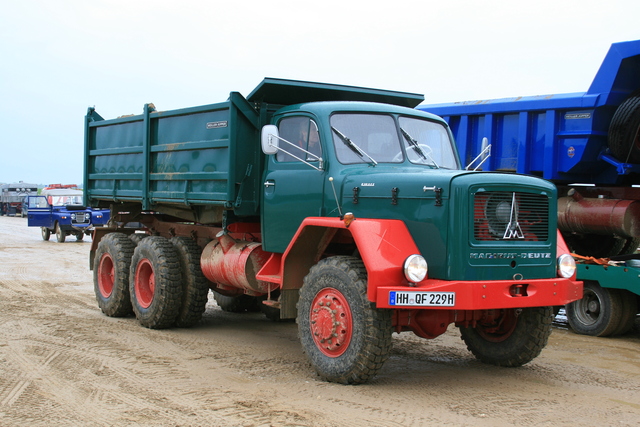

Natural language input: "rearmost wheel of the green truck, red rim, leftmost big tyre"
[93,233,135,317]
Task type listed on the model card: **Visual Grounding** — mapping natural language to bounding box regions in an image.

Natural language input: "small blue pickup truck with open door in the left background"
[27,189,110,243]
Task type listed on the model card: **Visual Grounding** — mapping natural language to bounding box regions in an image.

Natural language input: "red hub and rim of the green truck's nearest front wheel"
[309,288,353,357]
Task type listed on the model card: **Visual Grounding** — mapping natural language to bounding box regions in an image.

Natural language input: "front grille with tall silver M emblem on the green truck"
[473,191,549,241]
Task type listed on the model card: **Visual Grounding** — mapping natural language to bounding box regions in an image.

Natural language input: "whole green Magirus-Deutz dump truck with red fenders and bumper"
[84,79,582,384]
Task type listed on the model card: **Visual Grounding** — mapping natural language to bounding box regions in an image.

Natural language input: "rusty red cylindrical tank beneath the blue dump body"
[558,193,640,237]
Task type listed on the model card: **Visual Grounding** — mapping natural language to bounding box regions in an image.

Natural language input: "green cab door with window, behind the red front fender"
[261,116,326,253]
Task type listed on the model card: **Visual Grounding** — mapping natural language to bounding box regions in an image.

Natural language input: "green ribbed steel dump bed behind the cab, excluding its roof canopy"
[84,93,262,222]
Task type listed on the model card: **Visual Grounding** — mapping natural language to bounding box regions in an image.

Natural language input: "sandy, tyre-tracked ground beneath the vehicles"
[0,217,640,427]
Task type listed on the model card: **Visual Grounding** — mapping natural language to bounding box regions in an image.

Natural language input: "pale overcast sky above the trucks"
[0,0,640,184]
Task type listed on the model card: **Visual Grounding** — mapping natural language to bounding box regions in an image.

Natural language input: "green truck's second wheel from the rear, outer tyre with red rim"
[129,236,182,329]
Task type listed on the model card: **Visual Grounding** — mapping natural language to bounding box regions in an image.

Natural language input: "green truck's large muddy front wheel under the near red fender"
[297,256,392,384]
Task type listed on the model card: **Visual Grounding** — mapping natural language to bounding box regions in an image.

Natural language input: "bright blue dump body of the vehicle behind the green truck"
[417,40,640,184]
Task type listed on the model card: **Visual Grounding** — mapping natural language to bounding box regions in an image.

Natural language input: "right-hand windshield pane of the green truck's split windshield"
[398,117,460,169]
